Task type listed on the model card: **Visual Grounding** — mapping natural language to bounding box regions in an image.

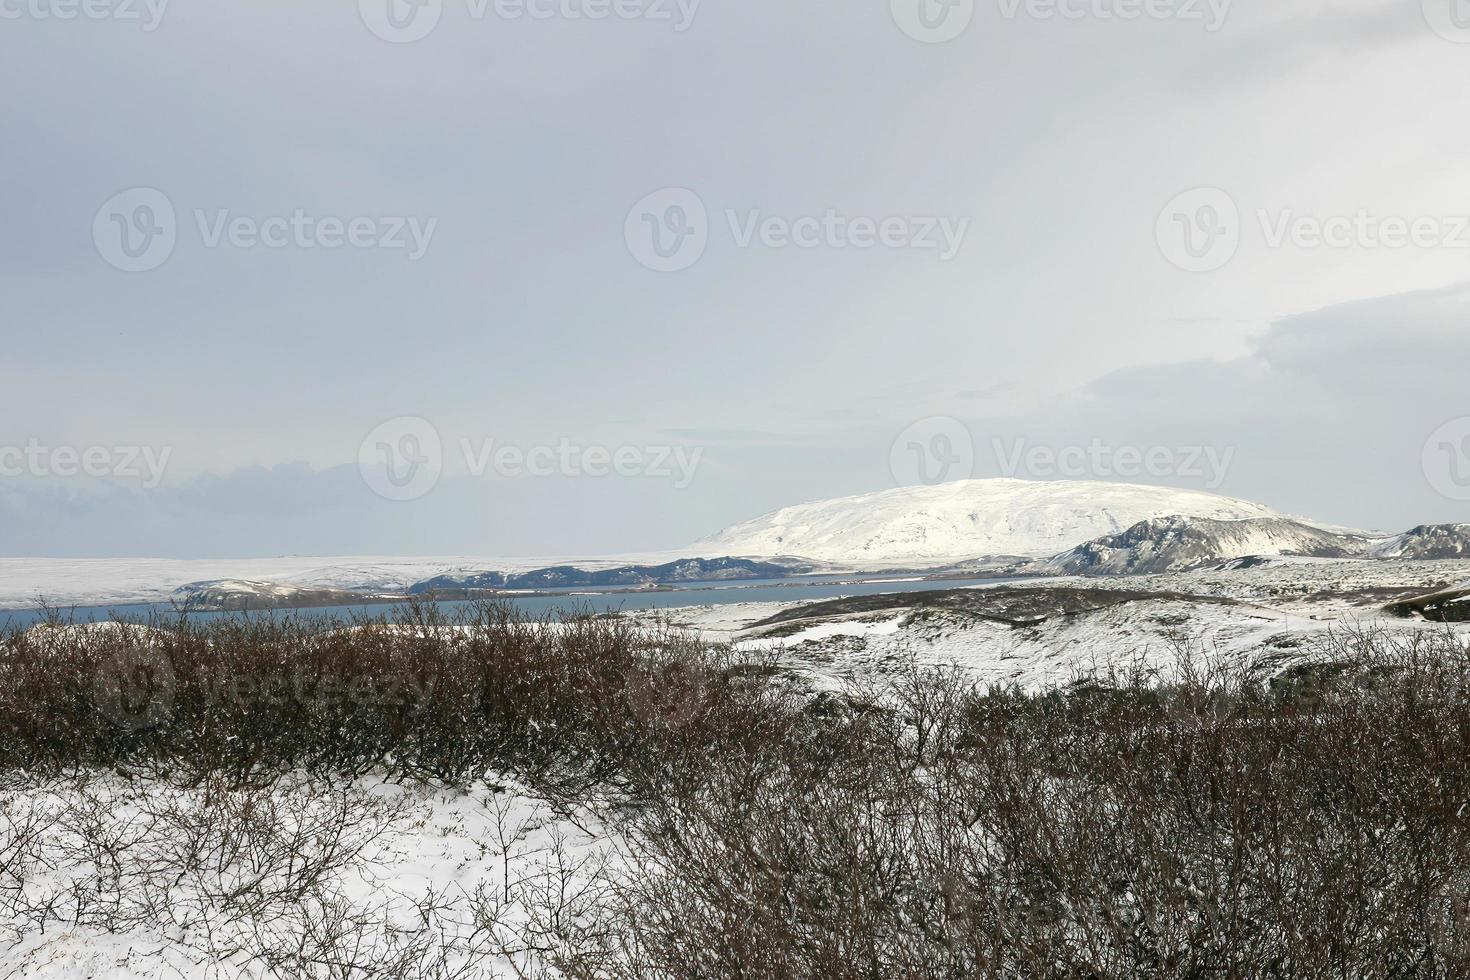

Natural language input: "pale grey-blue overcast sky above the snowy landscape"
[0,0,1470,557]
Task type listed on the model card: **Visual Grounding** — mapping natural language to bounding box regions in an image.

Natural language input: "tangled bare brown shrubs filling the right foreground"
[573,633,1470,979]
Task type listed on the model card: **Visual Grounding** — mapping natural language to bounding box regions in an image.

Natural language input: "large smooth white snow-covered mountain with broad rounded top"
[689,479,1283,567]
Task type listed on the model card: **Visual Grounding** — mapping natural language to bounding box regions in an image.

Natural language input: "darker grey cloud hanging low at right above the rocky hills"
[976,285,1470,527]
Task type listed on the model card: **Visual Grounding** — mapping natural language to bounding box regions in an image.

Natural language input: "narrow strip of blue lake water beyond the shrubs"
[0,576,1008,627]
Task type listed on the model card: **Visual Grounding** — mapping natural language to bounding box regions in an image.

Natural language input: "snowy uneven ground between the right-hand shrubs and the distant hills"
[632,560,1470,686]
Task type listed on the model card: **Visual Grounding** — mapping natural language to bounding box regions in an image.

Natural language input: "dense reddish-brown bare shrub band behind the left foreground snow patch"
[0,604,776,793]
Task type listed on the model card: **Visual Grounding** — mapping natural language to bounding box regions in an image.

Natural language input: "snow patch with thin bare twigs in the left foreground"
[0,776,617,980]
